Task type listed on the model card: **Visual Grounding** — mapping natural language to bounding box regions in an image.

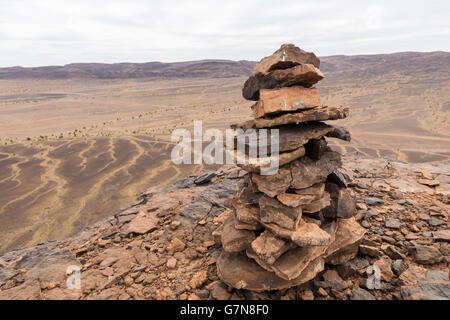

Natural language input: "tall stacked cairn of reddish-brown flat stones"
[214,44,364,292]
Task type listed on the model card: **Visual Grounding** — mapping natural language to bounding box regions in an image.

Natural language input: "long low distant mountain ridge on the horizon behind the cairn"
[0,51,450,79]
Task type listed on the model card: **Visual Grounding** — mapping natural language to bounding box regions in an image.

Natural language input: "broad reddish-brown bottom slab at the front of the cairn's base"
[217,251,324,292]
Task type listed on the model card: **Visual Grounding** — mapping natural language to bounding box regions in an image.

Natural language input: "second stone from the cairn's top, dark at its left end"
[242,64,324,101]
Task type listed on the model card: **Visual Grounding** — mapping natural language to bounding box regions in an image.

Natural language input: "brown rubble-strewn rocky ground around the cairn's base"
[0,155,450,300]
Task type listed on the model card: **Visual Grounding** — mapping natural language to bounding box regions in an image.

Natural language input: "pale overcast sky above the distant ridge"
[0,0,450,67]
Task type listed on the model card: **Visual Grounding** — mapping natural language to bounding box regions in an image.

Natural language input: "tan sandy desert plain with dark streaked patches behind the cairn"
[0,53,450,253]
